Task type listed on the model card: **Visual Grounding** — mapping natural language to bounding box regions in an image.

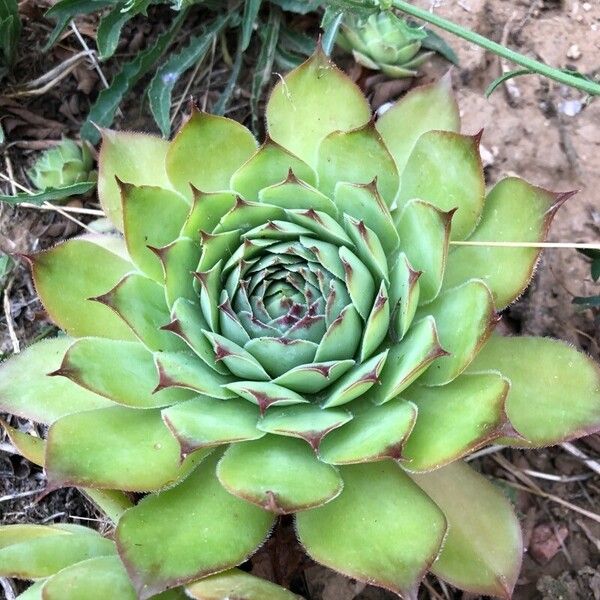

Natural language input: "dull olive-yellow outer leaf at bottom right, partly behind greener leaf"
[410,462,523,599]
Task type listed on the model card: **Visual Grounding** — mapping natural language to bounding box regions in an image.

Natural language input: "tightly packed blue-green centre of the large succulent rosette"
[190,205,390,406]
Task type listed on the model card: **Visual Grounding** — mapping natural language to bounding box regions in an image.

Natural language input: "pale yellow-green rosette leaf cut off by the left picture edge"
[0,336,112,425]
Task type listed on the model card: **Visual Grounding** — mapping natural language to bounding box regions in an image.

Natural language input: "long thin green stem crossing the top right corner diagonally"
[391,0,600,96]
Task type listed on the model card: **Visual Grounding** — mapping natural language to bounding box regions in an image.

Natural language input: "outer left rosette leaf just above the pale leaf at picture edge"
[30,235,135,340]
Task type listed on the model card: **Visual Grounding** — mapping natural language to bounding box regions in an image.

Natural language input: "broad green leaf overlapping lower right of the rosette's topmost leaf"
[317,122,399,206]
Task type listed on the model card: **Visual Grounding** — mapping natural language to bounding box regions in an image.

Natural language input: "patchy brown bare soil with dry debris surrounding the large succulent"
[0,0,600,600]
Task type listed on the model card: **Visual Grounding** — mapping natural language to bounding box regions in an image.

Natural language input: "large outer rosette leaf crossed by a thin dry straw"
[444,177,572,310]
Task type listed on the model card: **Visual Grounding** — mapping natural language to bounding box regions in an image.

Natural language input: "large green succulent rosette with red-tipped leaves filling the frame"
[0,53,600,598]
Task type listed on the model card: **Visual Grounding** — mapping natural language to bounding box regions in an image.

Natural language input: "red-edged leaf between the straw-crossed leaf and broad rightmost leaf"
[415,279,498,385]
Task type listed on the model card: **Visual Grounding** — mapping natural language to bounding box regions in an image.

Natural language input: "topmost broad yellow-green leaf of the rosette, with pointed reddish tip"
[266,50,371,166]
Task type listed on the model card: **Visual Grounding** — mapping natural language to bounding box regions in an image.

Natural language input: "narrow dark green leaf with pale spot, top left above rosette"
[147,13,231,138]
